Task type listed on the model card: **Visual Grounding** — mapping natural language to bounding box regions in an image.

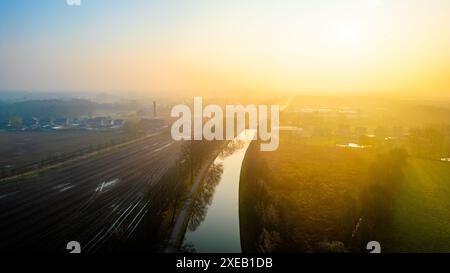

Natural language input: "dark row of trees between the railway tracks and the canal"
[120,140,225,251]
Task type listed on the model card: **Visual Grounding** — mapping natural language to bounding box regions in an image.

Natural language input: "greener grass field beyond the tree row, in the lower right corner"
[385,159,450,252]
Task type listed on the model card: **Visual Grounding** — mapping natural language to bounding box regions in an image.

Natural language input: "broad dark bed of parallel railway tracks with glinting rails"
[0,132,179,252]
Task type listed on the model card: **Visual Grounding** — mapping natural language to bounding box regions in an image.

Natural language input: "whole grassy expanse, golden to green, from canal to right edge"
[240,131,450,252]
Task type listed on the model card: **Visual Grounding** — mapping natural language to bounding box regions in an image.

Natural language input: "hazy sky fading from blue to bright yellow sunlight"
[0,0,450,97]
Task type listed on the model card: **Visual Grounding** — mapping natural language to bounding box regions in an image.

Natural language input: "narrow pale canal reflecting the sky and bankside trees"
[182,130,255,253]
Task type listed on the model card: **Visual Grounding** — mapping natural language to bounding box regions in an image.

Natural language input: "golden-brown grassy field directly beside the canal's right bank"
[240,133,373,252]
